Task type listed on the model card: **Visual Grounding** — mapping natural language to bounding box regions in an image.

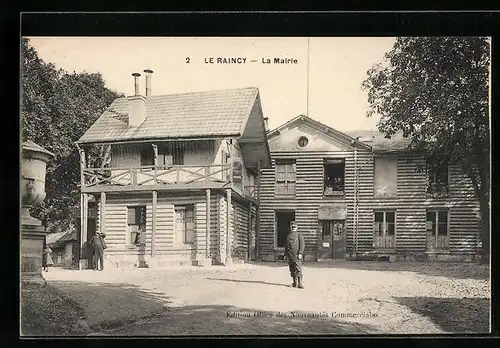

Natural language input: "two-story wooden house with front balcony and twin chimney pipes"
[77,70,270,267]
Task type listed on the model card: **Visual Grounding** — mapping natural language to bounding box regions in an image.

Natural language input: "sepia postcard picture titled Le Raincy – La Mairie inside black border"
[20,36,491,337]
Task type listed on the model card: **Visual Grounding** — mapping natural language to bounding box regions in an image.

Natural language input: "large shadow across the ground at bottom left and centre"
[34,279,379,336]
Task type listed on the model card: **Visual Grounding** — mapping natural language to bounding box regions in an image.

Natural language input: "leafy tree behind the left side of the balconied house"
[21,39,120,232]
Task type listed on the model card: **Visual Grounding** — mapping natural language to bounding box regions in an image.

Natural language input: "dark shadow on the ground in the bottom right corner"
[394,297,490,333]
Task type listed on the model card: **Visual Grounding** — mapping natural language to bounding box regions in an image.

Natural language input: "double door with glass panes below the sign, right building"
[318,220,345,259]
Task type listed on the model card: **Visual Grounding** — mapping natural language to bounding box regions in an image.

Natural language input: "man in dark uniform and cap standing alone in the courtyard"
[285,221,306,289]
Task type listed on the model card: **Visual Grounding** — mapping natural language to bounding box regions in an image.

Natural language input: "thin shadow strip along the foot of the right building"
[254,260,490,280]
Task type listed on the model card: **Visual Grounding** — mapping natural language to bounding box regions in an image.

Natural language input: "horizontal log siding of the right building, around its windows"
[259,150,478,259]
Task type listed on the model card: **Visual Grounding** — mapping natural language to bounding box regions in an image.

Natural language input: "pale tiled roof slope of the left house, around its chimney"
[77,87,259,143]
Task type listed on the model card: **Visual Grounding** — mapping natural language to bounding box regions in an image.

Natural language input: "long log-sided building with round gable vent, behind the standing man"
[257,116,479,261]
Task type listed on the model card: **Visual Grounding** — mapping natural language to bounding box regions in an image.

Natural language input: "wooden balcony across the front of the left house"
[81,164,231,193]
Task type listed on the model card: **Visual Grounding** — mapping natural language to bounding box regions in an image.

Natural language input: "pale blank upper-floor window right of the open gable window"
[373,156,398,197]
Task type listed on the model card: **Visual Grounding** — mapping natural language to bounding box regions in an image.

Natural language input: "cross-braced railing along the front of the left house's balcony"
[83,164,230,187]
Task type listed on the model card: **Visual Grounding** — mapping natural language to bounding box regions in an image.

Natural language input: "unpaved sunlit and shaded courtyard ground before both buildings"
[44,262,490,335]
